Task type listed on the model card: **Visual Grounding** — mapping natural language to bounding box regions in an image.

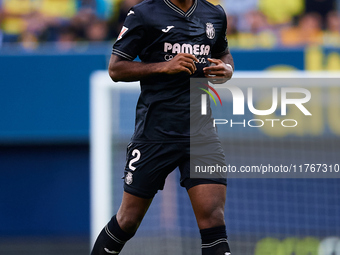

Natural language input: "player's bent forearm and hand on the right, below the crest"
[203,49,234,83]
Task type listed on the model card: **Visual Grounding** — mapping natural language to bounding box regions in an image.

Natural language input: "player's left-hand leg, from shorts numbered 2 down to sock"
[91,143,180,255]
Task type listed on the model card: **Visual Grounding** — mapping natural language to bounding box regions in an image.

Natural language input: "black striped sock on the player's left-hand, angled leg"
[91,215,135,255]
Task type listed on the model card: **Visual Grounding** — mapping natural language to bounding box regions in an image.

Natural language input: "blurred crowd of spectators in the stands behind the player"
[0,0,340,50]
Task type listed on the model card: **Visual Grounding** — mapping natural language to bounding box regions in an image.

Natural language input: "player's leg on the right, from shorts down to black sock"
[180,142,230,255]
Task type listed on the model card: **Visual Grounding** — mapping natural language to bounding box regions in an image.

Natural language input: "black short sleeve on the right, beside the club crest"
[211,6,228,58]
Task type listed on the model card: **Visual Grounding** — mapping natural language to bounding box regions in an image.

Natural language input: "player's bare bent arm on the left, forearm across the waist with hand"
[109,53,198,82]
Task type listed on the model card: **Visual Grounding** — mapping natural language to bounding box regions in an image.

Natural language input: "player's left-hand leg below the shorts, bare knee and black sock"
[91,192,152,255]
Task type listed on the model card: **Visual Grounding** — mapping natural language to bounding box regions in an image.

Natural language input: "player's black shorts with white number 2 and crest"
[123,141,227,198]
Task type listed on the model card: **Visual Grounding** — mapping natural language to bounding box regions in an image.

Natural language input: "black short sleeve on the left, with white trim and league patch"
[112,8,145,60]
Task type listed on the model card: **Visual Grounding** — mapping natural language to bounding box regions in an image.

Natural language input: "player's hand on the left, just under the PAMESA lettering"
[160,53,198,75]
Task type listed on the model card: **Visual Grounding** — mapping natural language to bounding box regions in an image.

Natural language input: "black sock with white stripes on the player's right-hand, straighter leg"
[200,225,230,255]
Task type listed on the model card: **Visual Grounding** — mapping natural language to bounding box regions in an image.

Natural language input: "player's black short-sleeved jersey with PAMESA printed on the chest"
[112,0,228,143]
